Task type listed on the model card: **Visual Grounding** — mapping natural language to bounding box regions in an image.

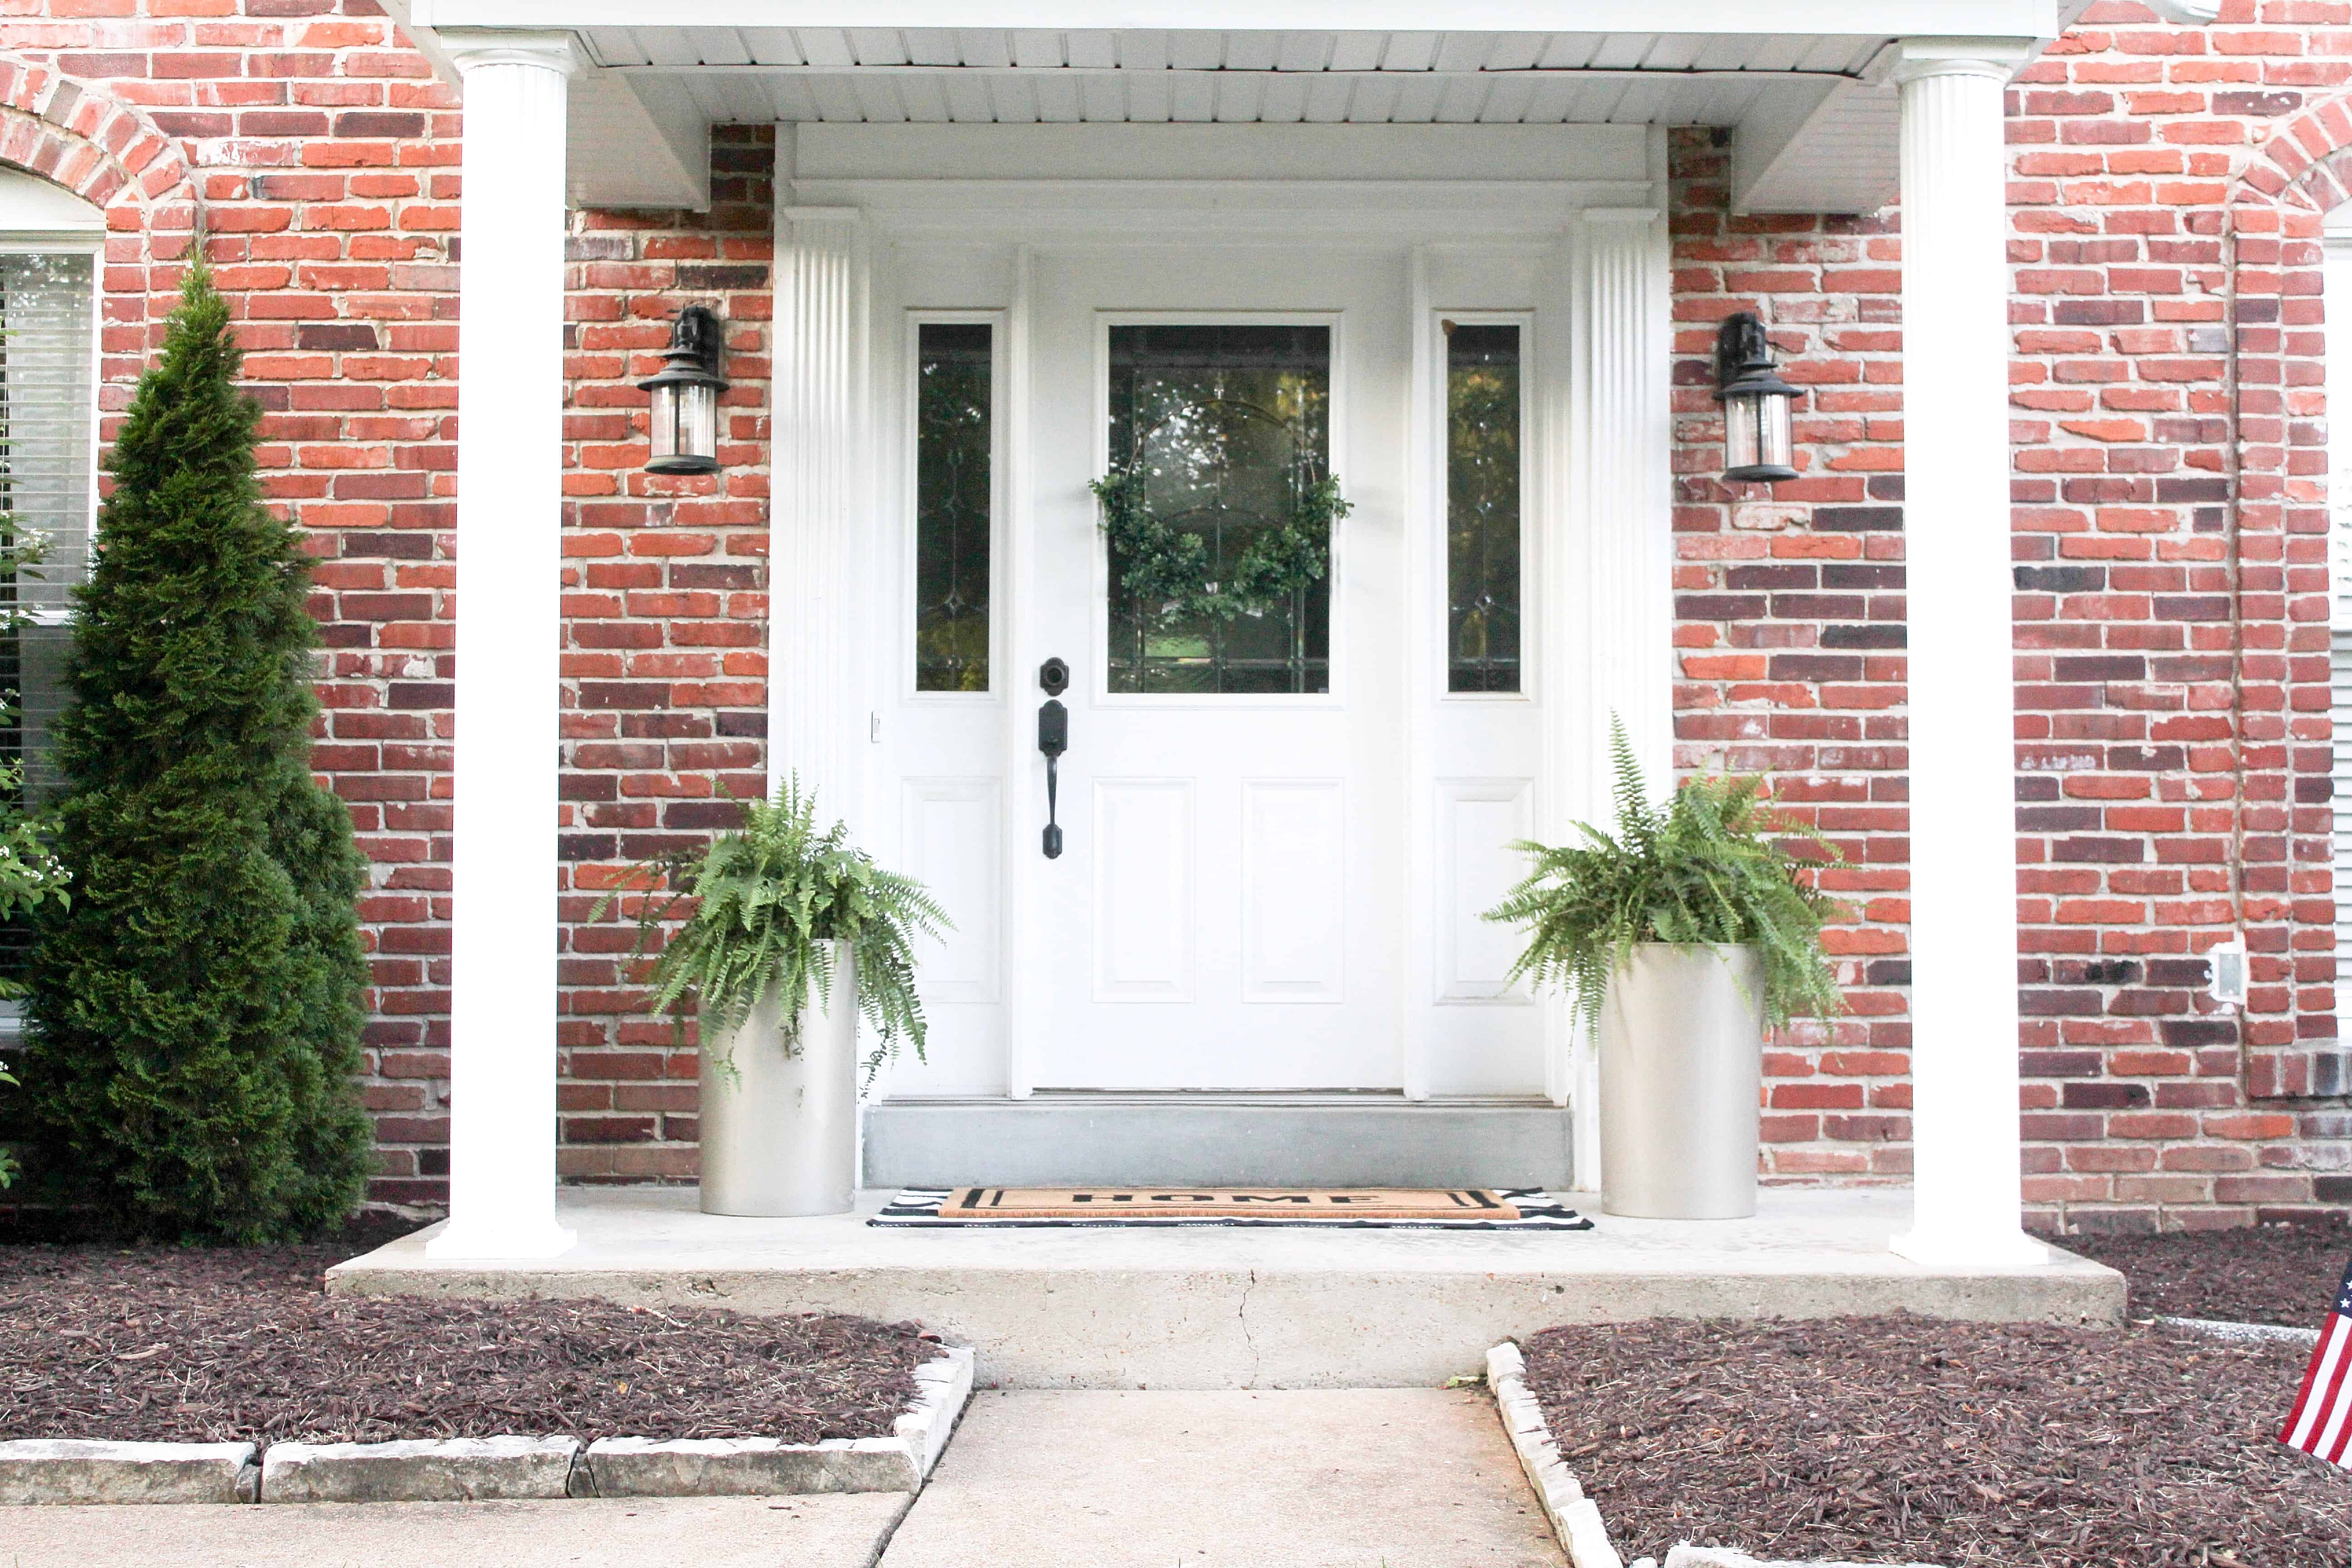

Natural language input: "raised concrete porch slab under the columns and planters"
[327,1187,2124,1389]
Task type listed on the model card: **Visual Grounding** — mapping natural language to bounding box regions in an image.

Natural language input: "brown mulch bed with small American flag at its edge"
[1522,1317,2352,1568]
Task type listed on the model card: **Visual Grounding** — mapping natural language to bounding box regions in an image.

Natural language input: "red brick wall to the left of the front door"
[0,0,774,1204]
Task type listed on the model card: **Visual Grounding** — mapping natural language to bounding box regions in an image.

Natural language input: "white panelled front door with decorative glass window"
[1019,249,1411,1088]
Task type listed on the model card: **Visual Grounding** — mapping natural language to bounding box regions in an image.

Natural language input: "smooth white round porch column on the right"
[1893,38,2046,1267]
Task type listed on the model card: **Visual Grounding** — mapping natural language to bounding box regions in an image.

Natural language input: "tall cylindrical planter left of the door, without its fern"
[701,943,858,1218]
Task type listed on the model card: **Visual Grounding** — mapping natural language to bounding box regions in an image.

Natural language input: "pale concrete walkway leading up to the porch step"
[0,1389,1564,1568]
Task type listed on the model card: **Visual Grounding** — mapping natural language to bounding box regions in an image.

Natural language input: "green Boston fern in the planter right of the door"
[1486,724,1846,1044]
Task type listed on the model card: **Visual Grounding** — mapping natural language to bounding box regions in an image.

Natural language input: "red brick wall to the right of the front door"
[1675,0,2352,1230]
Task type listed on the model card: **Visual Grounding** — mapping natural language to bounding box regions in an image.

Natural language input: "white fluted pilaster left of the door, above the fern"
[767,207,875,830]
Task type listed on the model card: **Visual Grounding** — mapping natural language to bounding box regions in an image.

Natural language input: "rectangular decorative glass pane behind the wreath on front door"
[1105,322,1345,696]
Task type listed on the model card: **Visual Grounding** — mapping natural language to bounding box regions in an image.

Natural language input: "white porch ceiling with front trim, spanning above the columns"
[386,0,2086,211]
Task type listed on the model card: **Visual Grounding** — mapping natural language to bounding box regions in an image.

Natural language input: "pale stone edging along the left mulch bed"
[0,1345,974,1504]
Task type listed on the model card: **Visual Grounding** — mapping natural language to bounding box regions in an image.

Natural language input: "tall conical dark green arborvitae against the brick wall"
[19,268,369,1241]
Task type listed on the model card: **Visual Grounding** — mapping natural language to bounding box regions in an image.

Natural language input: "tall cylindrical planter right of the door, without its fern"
[1599,943,1764,1220]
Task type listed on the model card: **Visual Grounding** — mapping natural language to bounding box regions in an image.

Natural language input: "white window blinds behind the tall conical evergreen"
[0,258,99,792]
